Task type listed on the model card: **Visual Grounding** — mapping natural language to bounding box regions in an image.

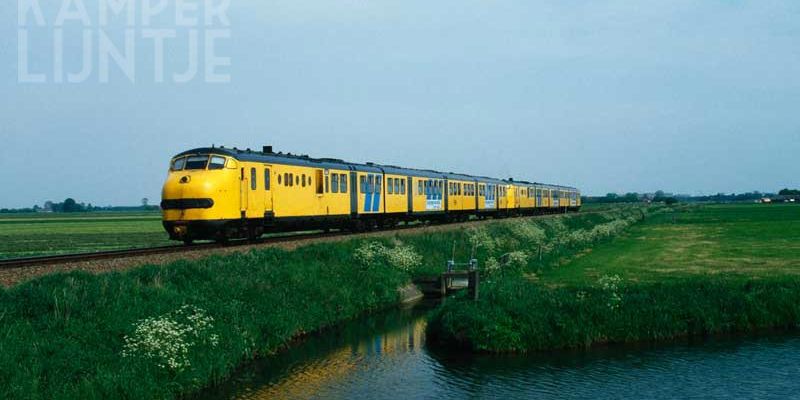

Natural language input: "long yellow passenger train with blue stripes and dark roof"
[161,146,581,243]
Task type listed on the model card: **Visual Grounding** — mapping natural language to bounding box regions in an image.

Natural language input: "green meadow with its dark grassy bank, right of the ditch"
[430,205,800,352]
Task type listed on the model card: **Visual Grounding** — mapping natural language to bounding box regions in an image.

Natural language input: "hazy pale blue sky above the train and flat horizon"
[0,0,800,207]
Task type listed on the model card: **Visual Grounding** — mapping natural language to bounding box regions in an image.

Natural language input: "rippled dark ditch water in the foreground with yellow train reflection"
[202,307,800,399]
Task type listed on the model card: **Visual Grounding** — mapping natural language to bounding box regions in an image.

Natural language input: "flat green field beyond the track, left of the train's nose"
[0,212,172,259]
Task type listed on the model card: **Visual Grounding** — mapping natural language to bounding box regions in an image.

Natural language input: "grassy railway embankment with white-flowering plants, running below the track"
[0,207,648,399]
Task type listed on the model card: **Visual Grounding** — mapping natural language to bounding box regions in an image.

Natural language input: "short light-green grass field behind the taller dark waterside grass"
[542,204,800,285]
